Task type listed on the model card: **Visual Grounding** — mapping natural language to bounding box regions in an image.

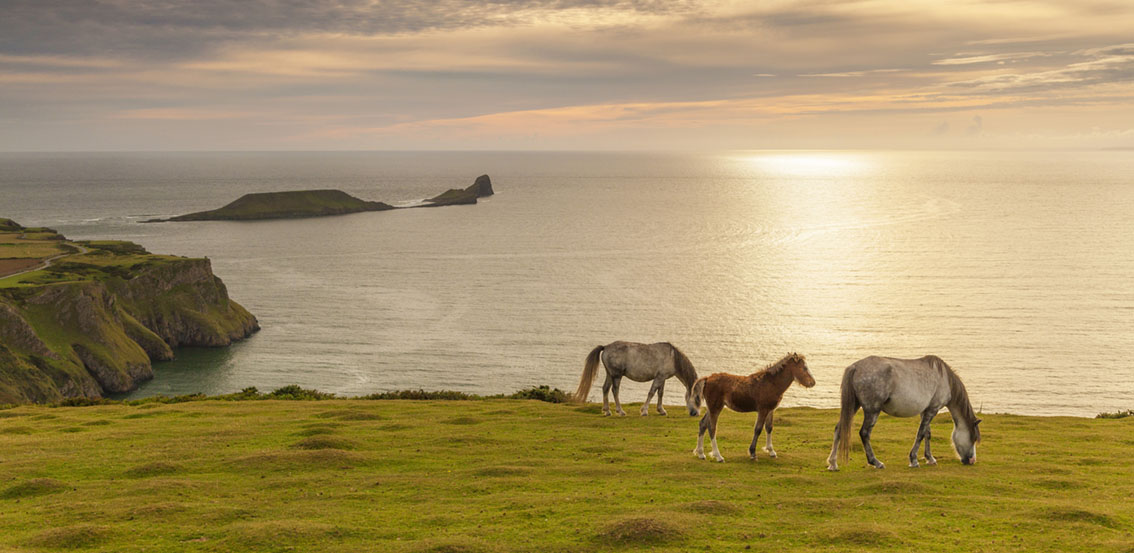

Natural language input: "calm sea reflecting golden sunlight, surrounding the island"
[0,152,1134,416]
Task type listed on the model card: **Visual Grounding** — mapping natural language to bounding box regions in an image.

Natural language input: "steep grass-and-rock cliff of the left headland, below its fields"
[0,231,260,403]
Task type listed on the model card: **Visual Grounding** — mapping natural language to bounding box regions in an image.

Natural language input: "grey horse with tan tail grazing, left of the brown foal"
[574,341,701,417]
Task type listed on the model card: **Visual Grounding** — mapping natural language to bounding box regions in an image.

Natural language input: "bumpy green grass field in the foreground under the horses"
[0,400,1134,552]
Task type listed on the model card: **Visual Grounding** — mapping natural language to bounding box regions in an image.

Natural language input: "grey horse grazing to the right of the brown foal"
[827,355,981,470]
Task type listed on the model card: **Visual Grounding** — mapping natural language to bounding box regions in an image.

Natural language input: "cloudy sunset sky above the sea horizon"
[0,0,1134,151]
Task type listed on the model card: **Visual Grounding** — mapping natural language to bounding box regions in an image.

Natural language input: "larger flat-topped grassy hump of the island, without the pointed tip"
[162,190,393,221]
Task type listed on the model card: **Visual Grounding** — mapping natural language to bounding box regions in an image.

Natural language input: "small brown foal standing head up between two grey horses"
[693,354,815,462]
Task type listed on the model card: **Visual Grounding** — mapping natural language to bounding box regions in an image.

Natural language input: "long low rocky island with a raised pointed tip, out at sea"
[143,175,493,223]
